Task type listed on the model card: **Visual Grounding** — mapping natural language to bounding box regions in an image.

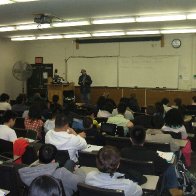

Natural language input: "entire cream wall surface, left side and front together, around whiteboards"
[0,34,196,98]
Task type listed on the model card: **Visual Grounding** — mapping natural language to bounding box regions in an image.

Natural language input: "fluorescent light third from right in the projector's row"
[92,17,135,24]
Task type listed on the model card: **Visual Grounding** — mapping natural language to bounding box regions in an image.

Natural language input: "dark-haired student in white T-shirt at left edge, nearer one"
[0,110,17,142]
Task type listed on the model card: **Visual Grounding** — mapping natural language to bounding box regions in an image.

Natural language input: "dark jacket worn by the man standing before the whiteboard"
[78,74,92,93]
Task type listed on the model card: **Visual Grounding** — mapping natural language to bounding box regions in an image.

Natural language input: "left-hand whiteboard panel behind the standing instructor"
[67,57,118,87]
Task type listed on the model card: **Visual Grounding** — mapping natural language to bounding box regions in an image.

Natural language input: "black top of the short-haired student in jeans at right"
[121,146,170,175]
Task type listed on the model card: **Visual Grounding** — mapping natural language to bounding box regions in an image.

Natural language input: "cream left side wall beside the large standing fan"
[0,39,23,99]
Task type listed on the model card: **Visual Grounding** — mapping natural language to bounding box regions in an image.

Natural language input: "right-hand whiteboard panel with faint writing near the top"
[119,56,179,88]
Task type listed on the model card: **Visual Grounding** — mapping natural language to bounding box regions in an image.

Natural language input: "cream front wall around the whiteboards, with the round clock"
[21,34,196,90]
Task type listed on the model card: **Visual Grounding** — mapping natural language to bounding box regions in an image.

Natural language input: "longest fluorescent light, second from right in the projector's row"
[136,14,186,22]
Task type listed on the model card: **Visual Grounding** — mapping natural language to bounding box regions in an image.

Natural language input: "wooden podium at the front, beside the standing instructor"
[47,82,75,105]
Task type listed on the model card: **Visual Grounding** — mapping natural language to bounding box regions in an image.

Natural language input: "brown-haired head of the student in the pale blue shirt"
[96,146,120,176]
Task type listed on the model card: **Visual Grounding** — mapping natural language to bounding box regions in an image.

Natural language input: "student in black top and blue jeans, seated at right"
[121,126,182,196]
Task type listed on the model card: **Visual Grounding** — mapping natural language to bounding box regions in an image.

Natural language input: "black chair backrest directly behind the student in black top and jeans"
[119,158,155,175]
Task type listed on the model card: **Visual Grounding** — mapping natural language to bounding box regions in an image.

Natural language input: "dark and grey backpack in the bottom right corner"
[175,160,196,195]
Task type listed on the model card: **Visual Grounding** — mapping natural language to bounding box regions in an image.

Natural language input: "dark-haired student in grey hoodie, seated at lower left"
[18,144,85,196]
